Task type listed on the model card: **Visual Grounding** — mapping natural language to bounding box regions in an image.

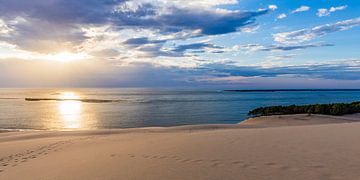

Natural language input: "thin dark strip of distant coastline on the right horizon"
[223,89,360,92]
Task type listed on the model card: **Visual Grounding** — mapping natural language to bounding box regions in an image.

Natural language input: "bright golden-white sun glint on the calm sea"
[58,92,82,129]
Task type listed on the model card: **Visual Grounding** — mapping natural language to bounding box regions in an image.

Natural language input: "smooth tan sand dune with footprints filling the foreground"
[0,115,360,180]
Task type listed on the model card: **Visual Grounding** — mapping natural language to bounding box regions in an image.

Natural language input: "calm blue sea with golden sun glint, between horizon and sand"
[0,89,360,130]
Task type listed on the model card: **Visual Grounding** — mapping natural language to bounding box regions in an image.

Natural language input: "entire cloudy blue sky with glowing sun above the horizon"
[0,0,360,89]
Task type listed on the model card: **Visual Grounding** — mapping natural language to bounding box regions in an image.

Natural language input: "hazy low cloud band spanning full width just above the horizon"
[0,56,360,87]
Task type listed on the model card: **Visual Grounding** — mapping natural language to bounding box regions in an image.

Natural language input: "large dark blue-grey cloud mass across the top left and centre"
[0,0,275,53]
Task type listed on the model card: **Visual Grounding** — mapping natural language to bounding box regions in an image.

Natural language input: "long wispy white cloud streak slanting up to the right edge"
[273,18,360,43]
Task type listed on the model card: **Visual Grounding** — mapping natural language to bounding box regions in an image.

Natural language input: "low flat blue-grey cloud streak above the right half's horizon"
[201,59,360,80]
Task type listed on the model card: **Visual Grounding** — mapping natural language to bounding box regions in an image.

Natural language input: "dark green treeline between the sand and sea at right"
[249,102,360,116]
